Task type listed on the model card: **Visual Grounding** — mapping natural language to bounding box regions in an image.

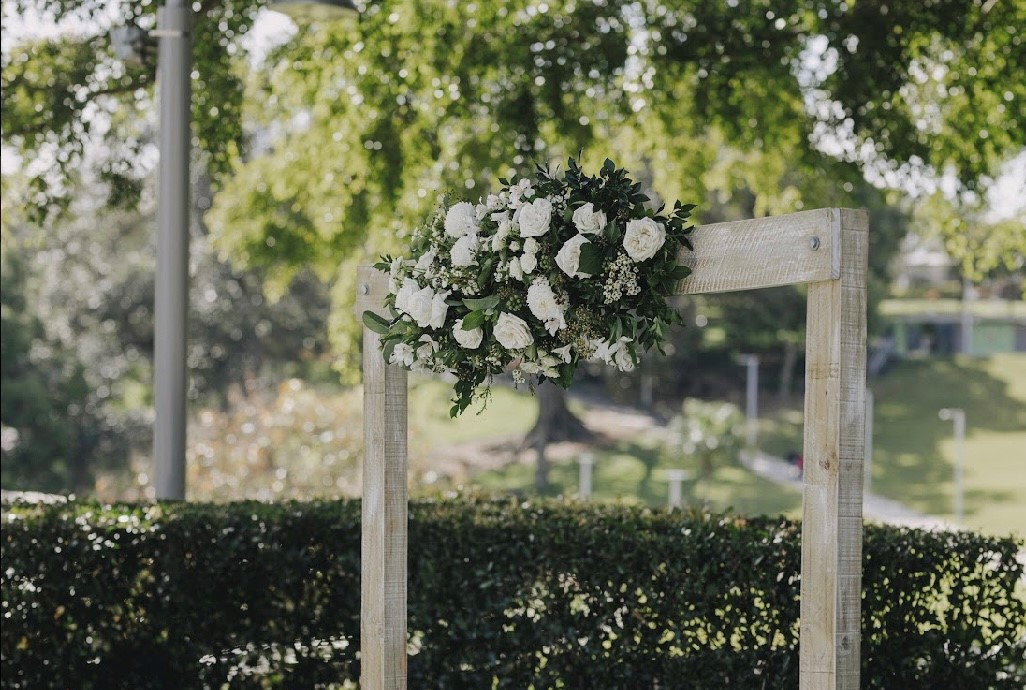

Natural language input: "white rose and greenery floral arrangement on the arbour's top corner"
[363,158,695,416]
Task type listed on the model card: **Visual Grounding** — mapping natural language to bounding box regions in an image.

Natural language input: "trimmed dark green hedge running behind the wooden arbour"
[0,498,1026,690]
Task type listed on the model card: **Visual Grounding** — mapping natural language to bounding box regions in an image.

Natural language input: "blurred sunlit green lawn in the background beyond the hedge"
[410,354,1026,535]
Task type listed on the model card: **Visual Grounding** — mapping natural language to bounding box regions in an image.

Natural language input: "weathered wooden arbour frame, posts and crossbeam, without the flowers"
[357,208,869,690]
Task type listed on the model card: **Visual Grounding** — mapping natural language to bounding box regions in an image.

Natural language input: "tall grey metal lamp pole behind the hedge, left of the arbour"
[153,0,192,500]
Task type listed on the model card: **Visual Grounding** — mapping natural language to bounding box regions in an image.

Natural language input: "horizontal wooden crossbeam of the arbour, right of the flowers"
[676,208,840,294]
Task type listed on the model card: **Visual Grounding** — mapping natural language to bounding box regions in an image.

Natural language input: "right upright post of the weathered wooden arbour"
[799,209,868,690]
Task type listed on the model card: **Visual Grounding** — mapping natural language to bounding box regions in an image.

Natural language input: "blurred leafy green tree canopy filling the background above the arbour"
[0,0,1026,496]
